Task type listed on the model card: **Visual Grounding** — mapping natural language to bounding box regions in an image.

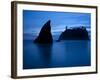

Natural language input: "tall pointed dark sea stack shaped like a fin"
[34,20,53,43]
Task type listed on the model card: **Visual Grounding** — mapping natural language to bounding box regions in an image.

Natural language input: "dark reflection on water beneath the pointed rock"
[35,44,52,67]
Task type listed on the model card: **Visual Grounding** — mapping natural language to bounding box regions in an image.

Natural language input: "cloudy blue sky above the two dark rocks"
[23,10,91,35]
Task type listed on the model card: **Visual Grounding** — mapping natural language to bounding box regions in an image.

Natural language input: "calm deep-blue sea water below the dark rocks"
[23,40,91,69]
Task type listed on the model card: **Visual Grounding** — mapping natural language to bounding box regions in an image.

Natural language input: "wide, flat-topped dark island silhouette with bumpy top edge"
[58,27,89,41]
